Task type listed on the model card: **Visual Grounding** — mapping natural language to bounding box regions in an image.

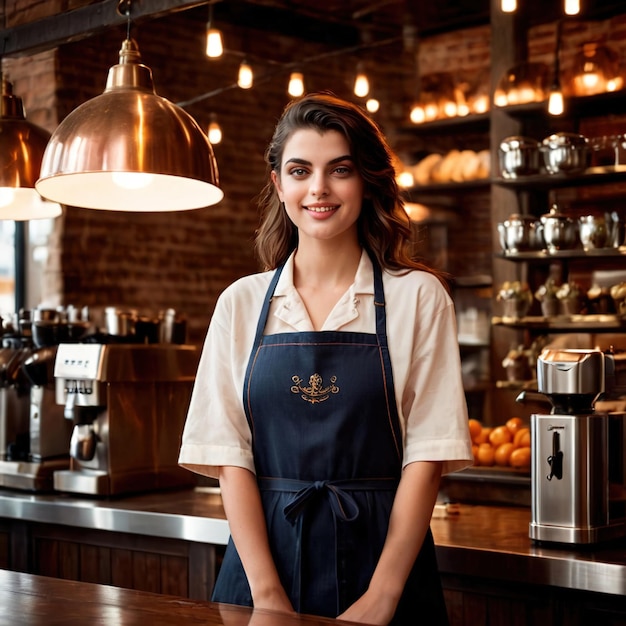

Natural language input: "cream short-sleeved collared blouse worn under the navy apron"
[179,252,473,477]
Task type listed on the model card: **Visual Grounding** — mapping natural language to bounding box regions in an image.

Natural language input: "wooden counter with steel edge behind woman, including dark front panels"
[0,488,626,626]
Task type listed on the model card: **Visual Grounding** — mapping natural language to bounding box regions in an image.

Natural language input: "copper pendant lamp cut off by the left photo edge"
[0,78,62,221]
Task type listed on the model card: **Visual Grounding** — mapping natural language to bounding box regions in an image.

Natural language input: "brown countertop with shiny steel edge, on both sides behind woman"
[0,487,626,596]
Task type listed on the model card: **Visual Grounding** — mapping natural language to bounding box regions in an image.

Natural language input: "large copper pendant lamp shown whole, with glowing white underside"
[36,36,224,212]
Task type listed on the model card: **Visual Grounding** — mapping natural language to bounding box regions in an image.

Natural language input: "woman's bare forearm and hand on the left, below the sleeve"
[219,465,293,613]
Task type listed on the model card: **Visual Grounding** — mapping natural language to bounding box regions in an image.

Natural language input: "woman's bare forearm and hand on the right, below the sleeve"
[339,461,442,625]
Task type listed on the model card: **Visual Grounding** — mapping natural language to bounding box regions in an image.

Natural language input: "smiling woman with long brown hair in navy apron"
[180,94,472,624]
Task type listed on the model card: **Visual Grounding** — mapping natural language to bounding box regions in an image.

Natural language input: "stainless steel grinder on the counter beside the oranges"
[529,349,626,544]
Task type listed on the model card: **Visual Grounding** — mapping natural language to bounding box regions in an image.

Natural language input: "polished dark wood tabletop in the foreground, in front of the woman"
[0,570,353,626]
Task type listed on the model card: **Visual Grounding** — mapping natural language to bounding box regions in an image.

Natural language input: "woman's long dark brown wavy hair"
[255,92,445,284]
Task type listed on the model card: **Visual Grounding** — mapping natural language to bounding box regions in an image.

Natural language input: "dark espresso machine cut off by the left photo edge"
[0,311,71,491]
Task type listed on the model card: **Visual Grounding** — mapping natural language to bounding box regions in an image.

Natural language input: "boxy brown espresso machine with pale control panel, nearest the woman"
[54,343,199,496]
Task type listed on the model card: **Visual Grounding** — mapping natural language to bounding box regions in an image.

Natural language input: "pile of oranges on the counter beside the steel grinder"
[469,417,530,469]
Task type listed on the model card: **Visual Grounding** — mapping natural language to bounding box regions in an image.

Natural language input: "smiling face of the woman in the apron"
[272,128,364,245]
